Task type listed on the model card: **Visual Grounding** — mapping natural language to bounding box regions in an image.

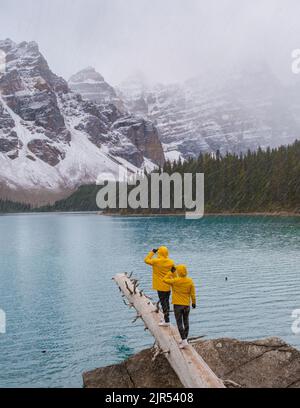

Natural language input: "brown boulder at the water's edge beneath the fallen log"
[83,338,300,388]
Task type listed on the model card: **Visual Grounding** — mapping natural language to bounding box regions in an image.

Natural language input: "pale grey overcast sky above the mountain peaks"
[0,0,300,84]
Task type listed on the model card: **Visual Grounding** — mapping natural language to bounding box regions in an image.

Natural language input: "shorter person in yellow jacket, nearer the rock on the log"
[164,265,196,348]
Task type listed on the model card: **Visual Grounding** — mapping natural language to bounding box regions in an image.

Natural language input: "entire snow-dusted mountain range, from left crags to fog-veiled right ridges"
[0,39,300,201]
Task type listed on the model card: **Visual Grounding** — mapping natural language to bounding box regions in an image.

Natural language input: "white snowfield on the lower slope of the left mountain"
[0,93,139,190]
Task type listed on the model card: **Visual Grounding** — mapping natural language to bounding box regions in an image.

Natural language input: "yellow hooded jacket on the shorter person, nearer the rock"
[164,265,196,306]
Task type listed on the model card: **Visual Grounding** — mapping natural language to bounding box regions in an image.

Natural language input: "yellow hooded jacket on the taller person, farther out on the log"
[145,247,175,292]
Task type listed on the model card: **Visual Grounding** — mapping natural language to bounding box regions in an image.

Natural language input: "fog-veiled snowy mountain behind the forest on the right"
[117,64,300,160]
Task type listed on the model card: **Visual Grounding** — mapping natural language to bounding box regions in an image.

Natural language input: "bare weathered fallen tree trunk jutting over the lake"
[114,274,225,388]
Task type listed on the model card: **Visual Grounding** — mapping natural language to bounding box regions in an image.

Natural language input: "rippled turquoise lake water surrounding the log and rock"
[0,214,300,387]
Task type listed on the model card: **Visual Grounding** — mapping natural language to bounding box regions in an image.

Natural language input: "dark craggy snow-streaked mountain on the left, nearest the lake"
[0,40,164,199]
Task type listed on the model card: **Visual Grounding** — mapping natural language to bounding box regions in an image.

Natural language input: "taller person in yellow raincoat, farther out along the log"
[145,246,175,326]
